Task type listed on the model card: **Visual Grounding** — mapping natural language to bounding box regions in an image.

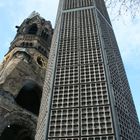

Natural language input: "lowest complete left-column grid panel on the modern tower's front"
[49,109,79,137]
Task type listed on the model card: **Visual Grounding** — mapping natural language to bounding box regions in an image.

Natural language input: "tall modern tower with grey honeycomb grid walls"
[36,0,140,140]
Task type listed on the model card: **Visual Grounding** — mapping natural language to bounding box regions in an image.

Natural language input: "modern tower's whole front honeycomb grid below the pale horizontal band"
[49,6,114,140]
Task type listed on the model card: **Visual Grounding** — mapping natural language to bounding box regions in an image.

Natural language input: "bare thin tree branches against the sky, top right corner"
[105,0,140,18]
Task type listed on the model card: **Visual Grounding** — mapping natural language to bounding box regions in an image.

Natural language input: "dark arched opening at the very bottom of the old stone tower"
[0,124,34,140]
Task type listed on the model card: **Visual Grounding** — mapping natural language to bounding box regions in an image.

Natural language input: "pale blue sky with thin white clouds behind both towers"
[0,0,140,120]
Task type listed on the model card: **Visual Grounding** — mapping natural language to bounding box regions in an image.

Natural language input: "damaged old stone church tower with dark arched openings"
[0,12,53,140]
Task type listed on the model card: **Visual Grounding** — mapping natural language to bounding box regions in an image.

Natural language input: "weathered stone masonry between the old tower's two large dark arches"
[0,91,37,138]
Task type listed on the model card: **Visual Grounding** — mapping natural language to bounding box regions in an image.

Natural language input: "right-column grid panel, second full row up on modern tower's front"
[80,82,109,107]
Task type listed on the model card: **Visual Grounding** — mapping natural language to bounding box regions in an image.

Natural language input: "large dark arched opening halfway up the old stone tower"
[15,81,42,115]
